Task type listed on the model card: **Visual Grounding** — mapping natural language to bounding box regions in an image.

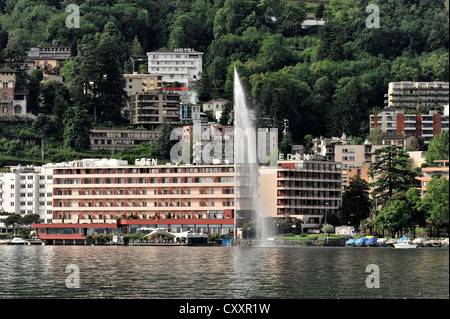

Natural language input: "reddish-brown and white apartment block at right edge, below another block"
[370,108,449,142]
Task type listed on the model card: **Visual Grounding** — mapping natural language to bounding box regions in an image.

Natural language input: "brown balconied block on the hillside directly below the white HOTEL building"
[128,90,181,130]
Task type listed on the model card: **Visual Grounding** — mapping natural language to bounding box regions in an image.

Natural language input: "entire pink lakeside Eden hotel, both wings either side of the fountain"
[33,159,341,242]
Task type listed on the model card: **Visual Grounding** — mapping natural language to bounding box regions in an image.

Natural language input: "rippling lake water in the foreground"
[0,245,449,299]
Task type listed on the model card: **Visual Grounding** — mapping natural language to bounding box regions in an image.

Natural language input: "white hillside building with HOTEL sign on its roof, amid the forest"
[147,48,203,87]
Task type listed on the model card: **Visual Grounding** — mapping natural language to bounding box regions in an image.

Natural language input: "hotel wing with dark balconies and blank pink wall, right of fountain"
[259,155,342,231]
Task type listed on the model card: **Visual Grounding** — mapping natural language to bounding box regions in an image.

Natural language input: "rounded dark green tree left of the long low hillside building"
[63,106,92,151]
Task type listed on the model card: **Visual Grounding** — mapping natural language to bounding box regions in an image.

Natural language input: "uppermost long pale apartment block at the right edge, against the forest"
[385,81,449,109]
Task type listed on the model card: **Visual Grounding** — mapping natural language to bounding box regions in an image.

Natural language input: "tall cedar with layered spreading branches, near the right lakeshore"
[369,145,415,205]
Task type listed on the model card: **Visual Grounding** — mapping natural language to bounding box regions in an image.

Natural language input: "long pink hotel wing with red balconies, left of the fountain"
[29,159,234,239]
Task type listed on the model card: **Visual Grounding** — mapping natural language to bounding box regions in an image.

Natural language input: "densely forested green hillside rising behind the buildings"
[0,0,449,149]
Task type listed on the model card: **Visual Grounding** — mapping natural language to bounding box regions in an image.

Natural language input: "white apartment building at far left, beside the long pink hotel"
[0,164,54,228]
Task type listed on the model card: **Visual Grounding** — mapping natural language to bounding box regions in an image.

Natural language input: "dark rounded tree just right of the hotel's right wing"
[341,175,372,226]
